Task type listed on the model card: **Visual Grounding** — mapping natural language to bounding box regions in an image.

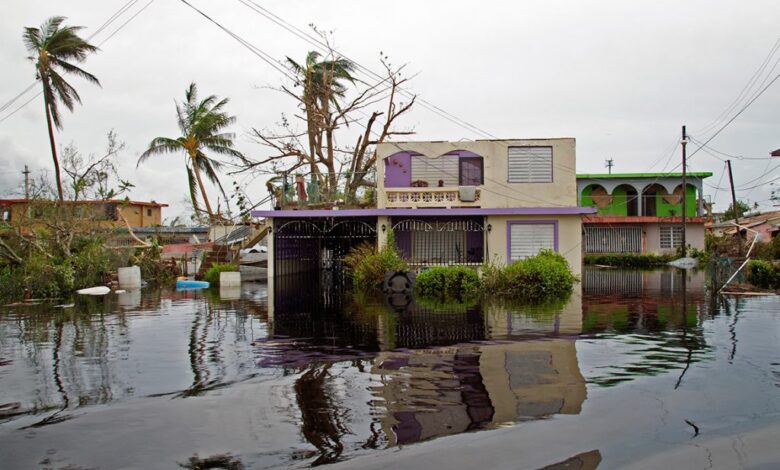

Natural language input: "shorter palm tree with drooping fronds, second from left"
[138,82,244,221]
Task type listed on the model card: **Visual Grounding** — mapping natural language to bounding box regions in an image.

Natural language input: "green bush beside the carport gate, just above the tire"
[344,230,409,292]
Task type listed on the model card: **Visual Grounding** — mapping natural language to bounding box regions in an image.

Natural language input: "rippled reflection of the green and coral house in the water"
[582,269,712,386]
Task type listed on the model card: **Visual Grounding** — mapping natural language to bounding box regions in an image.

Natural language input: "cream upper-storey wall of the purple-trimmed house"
[377,138,577,208]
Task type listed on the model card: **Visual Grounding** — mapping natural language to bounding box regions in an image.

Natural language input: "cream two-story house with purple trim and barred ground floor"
[252,138,595,300]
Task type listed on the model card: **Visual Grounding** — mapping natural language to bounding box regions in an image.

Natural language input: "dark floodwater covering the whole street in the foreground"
[0,270,780,469]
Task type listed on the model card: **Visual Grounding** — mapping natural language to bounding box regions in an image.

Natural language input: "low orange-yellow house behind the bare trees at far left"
[0,199,168,228]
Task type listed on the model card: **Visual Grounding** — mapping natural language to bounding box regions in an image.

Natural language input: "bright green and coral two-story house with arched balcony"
[577,172,712,254]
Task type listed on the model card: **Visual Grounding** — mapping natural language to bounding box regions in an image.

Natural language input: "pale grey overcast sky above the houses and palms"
[0,0,780,217]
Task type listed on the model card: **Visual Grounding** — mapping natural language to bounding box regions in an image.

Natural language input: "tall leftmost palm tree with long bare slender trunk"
[22,16,100,201]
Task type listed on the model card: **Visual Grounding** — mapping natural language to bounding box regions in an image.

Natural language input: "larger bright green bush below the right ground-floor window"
[482,250,577,302]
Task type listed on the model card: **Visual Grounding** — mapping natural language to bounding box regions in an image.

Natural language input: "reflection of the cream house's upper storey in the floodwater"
[372,339,586,445]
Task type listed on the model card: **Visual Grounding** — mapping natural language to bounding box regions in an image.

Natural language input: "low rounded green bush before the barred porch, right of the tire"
[414,266,482,302]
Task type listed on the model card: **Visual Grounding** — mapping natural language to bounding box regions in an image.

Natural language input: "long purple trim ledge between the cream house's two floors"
[252,207,596,219]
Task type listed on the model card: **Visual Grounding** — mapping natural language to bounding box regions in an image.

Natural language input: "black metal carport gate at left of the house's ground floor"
[273,217,376,303]
